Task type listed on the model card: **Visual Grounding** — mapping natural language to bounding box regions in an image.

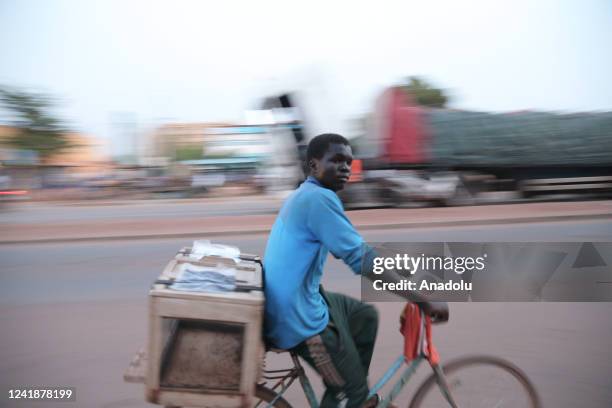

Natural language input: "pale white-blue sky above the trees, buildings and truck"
[0,0,612,154]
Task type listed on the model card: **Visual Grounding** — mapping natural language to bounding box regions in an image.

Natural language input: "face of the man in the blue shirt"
[309,143,353,191]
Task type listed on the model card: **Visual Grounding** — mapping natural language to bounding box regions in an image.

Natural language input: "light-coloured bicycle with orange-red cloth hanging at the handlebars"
[255,304,541,408]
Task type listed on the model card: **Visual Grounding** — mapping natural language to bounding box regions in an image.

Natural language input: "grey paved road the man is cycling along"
[0,220,612,408]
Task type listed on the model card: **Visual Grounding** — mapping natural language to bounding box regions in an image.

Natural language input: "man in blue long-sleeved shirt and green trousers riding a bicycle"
[264,133,448,408]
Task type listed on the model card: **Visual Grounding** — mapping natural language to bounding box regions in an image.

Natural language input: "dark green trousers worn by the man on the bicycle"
[293,290,378,408]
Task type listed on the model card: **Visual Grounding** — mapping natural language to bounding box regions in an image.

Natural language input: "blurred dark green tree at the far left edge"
[0,87,75,162]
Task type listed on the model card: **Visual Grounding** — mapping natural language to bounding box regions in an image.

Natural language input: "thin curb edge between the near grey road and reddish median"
[0,213,612,245]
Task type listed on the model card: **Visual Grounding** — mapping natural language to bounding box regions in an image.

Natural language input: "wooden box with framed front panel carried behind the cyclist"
[145,254,264,407]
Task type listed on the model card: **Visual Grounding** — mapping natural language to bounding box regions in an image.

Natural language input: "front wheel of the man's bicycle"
[410,356,541,408]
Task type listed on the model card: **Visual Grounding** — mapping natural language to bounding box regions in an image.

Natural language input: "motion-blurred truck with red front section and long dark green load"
[258,87,612,208]
